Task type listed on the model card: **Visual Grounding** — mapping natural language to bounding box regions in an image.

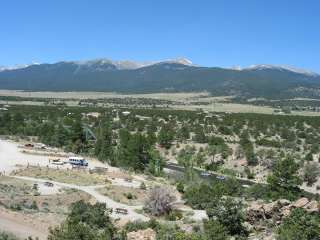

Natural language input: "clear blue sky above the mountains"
[0,0,320,72]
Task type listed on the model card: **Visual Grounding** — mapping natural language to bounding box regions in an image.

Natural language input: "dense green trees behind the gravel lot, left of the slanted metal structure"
[0,107,89,153]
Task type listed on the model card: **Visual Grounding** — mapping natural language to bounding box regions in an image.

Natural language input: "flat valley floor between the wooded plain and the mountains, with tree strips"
[0,90,320,116]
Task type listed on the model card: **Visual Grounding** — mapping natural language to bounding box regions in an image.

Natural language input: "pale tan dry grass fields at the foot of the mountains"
[0,90,320,116]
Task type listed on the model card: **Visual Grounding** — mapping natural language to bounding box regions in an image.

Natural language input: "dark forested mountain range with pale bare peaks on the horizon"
[0,58,320,99]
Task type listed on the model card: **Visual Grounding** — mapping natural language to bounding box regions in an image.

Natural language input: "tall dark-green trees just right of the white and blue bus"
[95,123,164,176]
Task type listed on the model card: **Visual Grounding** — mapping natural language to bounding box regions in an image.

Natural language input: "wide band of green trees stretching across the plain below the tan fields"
[0,106,320,174]
